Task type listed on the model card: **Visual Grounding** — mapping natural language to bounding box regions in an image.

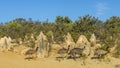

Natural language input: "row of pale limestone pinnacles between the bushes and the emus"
[0,32,116,58]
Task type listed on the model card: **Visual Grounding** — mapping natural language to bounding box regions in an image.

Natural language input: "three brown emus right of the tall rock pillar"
[56,45,108,61]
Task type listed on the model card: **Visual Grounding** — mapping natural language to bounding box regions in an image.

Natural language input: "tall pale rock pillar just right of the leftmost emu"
[36,32,50,58]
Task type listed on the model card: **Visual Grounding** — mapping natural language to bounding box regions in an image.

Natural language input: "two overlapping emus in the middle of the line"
[56,45,85,61]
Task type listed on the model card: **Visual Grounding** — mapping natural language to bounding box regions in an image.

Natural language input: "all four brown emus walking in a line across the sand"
[25,45,107,61]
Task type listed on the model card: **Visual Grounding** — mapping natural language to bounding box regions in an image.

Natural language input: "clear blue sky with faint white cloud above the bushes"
[0,0,120,23]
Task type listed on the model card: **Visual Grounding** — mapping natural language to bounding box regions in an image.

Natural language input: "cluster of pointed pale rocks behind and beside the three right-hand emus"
[62,33,117,58]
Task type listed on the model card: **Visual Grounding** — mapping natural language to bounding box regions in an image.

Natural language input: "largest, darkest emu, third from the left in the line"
[68,46,85,60]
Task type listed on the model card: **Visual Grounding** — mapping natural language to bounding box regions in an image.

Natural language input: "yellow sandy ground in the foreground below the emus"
[0,52,120,68]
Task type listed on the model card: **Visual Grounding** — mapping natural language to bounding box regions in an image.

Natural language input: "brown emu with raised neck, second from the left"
[56,45,70,62]
